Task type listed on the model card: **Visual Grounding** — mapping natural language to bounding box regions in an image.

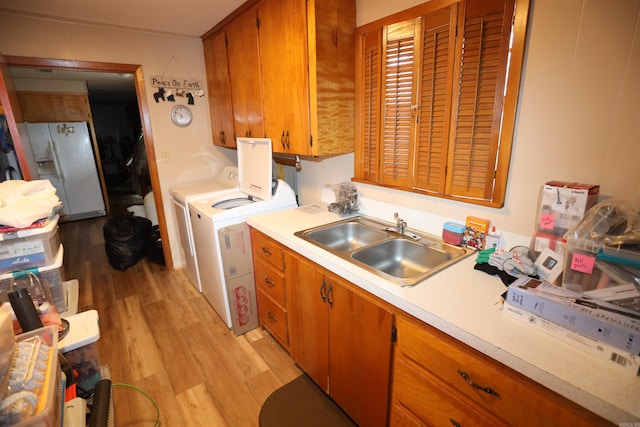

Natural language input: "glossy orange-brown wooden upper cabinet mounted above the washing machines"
[204,0,356,156]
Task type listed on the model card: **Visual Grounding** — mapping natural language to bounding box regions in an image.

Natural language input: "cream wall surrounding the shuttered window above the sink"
[300,0,640,239]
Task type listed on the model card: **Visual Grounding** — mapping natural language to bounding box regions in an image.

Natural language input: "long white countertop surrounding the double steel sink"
[247,204,640,424]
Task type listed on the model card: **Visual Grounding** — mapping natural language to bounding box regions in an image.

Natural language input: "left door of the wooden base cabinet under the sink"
[287,257,329,393]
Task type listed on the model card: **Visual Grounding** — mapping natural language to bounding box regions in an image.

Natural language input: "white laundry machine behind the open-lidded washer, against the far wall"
[170,166,238,292]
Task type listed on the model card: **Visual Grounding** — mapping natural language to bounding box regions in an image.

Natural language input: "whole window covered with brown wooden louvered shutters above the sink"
[354,0,530,207]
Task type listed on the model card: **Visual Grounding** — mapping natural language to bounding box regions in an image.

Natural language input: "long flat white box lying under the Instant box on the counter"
[502,302,640,376]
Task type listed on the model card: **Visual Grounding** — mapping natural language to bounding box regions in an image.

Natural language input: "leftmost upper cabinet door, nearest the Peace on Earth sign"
[203,31,236,148]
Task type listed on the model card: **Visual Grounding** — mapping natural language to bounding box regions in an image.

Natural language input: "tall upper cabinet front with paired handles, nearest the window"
[258,0,310,154]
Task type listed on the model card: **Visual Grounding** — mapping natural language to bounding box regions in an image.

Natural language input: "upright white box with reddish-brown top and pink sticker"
[537,181,600,236]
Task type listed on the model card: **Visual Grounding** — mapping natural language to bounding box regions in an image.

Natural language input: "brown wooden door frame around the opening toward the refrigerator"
[0,55,173,270]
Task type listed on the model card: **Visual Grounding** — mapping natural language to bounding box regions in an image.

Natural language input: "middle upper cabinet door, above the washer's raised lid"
[227,7,264,138]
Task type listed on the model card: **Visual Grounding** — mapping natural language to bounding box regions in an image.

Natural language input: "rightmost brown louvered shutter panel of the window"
[448,0,514,200]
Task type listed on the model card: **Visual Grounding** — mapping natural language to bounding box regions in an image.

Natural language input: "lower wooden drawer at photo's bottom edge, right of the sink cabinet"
[391,357,503,427]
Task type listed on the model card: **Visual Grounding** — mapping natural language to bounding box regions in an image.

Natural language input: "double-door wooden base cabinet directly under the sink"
[289,257,393,427]
